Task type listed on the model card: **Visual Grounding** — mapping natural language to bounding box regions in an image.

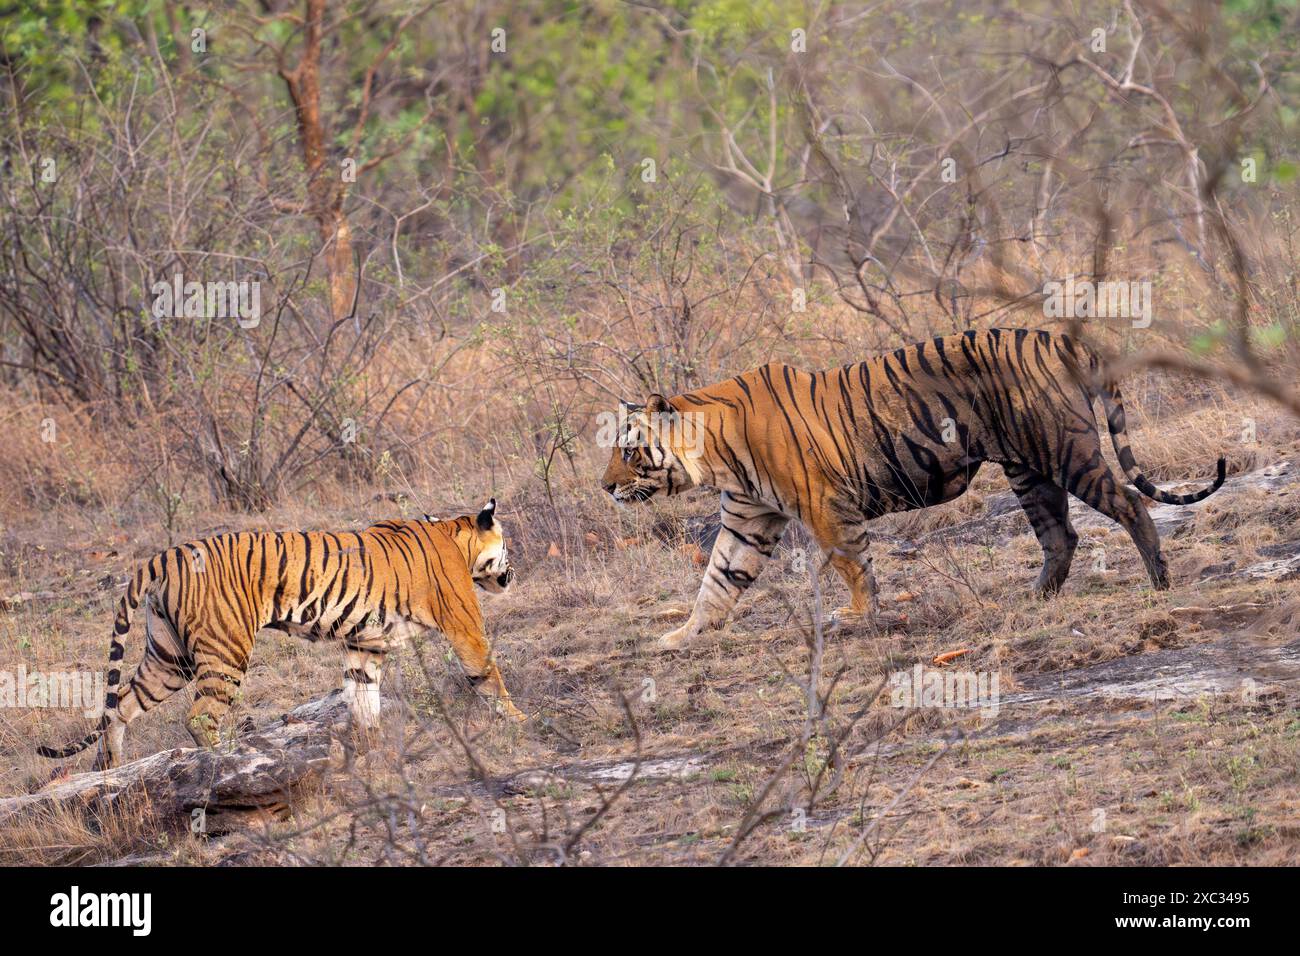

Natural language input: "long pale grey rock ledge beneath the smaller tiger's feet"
[0,691,379,832]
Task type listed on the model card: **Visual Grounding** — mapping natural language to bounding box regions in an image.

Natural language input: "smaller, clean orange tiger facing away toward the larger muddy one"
[38,498,524,769]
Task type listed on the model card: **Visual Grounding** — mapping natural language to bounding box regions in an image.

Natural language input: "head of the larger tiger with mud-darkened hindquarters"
[601,394,696,505]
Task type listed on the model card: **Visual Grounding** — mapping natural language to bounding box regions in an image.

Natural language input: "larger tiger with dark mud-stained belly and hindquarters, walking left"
[603,329,1225,649]
